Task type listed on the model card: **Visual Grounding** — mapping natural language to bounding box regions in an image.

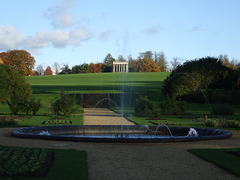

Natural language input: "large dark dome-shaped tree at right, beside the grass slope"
[162,57,239,97]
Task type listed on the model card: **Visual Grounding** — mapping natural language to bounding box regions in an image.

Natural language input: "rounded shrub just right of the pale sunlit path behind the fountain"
[135,96,156,117]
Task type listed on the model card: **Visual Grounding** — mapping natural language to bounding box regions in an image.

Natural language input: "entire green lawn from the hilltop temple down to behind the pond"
[0,72,240,127]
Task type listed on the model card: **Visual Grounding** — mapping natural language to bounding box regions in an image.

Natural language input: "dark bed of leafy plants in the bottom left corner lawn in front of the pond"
[0,148,53,177]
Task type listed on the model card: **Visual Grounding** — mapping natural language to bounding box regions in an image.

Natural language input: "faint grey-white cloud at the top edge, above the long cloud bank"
[44,0,76,28]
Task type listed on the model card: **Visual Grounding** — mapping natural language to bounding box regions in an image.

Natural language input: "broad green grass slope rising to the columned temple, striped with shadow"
[26,72,170,94]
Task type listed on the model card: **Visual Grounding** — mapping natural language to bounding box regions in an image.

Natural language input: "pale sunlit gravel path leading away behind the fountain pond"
[84,108,134,125]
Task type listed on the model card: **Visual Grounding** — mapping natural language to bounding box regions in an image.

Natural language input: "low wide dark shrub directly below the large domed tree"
[160,98,187,115]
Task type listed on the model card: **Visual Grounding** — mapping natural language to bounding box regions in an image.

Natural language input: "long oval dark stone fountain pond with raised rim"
[12,125,232,143]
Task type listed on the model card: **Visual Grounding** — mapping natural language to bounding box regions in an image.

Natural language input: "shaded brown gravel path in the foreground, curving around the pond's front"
[0,109,240,180]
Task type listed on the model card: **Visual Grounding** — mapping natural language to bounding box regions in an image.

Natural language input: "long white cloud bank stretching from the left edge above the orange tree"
[0,26,93,52]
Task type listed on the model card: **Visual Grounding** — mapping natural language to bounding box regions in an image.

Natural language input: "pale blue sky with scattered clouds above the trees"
[0,0,240,67]
